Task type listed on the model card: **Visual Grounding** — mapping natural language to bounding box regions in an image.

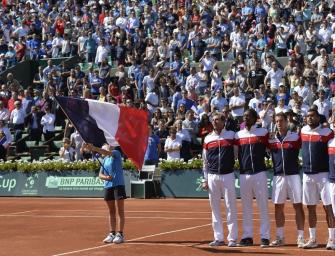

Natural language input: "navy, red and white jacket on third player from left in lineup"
[268,131,301,176]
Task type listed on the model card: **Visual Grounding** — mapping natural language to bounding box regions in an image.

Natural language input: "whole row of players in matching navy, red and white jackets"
[203,109,335,250]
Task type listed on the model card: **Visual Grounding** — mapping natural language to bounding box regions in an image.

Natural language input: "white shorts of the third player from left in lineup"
[272,174,302,204]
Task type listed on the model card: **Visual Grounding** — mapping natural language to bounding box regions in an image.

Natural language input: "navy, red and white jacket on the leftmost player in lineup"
[203,130,235,179]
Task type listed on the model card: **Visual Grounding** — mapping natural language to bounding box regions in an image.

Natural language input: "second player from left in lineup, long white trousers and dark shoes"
[235,109,270,247]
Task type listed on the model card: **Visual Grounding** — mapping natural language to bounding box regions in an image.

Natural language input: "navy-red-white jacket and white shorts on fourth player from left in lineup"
[301,125,334,205]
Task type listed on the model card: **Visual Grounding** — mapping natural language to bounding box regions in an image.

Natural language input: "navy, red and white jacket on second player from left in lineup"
[235,126,269,174]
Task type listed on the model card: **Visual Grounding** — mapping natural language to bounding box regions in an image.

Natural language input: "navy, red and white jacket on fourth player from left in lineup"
[301,125,334,174]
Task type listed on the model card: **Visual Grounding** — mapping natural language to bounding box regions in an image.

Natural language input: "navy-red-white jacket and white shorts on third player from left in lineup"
[268,131,302,204]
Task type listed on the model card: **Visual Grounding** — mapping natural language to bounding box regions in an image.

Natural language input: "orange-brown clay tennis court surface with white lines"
[0,198,335,256]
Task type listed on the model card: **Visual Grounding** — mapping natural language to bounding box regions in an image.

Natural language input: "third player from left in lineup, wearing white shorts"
[269,112,305,248]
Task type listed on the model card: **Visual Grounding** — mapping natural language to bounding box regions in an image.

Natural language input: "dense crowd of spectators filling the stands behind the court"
[0,0,335,161]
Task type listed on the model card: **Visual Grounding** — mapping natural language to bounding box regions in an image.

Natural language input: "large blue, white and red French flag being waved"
[55,96,149,169]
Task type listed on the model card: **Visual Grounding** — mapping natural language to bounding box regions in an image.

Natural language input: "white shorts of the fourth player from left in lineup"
[302,172,331,205]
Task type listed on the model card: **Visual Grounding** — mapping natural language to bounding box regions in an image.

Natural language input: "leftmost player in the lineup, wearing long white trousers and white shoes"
[203,113,238,247]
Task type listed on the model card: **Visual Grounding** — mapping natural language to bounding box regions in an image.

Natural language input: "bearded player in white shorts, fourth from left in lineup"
[301,109,335,249]
